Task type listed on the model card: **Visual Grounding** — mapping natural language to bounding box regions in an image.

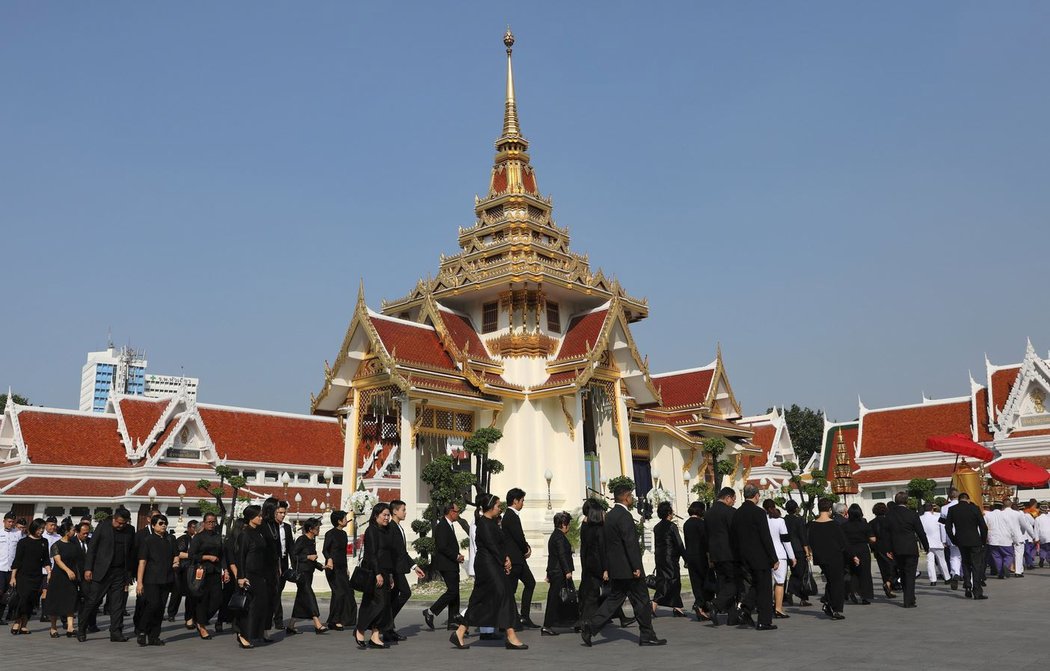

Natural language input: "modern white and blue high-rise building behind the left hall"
[80,343,197,413]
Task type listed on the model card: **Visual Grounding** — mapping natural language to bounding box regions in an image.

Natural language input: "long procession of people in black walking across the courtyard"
[0,484,1033,650]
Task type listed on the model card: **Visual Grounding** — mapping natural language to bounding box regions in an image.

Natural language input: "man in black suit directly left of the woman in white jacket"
[730,483,780,631]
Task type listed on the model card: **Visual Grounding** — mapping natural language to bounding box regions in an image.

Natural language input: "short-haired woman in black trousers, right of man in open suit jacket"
[134,515,179,646]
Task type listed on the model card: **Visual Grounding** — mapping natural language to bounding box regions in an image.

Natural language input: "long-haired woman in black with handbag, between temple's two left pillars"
[354,503,394,650]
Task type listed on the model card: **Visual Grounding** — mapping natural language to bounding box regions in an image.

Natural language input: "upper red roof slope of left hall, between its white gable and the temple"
[197,405,343,466]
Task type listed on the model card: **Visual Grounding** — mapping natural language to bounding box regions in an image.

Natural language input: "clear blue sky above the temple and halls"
[0,0,1050,419]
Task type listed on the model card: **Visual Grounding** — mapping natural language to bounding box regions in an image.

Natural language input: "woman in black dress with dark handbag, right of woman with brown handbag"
[236,505,278,648]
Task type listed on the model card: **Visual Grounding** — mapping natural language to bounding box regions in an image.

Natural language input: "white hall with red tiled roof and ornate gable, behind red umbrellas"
[820,341,1050,502]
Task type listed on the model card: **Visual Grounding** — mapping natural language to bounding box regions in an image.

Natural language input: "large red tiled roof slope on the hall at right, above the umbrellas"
[860,399,970,457]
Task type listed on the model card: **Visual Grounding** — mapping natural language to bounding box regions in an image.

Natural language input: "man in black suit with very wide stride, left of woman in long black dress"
[581,484,667,648]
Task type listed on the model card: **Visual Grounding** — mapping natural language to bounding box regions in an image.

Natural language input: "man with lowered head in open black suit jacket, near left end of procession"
[77,508,134,643]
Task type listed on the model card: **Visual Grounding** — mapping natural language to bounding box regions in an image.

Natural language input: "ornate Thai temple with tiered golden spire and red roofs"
[311,30,776,533]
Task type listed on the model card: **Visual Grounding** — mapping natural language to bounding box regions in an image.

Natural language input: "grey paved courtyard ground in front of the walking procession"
[0,569,1050,671]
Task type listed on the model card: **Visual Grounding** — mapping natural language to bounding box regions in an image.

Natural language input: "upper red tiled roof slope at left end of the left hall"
[18,408,129,467]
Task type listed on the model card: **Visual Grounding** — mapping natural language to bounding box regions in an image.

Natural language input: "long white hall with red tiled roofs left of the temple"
[0,387,343,523]
